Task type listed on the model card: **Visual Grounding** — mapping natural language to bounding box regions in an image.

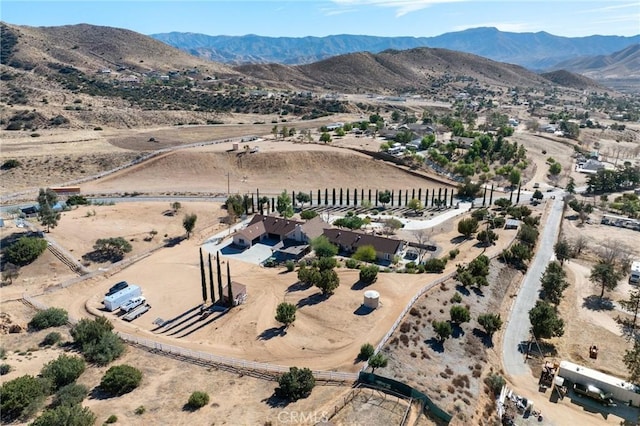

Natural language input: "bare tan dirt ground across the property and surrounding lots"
[0,118,635,425]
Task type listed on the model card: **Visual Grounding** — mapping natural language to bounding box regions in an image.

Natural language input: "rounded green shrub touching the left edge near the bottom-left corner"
[0,375,49,422]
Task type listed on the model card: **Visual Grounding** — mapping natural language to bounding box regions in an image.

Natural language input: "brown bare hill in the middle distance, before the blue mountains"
[234,47,572,94]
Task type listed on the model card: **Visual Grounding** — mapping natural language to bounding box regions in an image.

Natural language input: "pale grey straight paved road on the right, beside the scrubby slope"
[502,192,563,376]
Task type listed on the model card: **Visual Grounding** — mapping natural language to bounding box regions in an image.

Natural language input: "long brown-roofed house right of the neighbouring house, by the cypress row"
[322,228,404,261]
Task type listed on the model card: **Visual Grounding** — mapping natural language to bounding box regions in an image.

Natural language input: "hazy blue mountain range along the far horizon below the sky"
[151,27,640,72]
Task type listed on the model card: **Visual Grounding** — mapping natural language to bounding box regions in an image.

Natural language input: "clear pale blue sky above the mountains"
[0,0,640,37]
